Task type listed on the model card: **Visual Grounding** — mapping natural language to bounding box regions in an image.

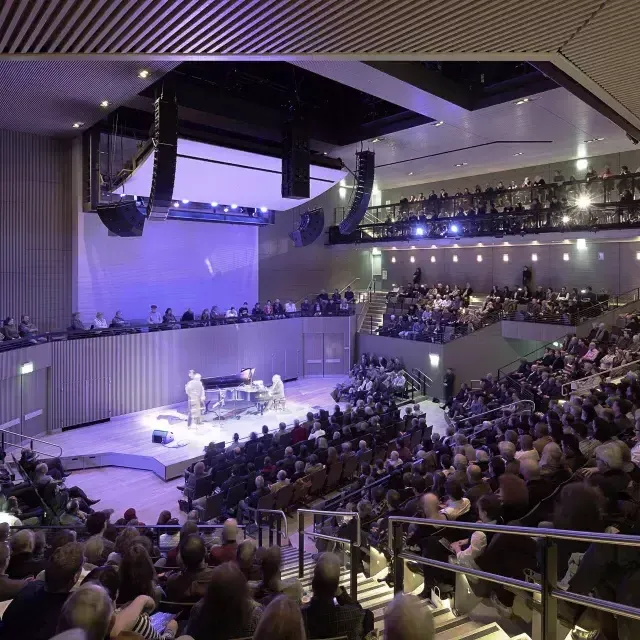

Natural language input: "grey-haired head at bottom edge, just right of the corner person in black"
[57,583,115,640]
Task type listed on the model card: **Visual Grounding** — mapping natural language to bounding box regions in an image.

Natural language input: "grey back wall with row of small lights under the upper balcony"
[382,241,640,293]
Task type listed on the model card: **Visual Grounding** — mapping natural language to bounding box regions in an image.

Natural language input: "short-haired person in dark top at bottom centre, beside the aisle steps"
[302,553,367,640]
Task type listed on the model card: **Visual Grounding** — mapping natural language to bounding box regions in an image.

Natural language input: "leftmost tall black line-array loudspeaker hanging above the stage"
[147,87,178,220]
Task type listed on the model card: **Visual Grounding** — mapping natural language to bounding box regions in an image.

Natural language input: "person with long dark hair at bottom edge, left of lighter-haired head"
[186,562,263,640]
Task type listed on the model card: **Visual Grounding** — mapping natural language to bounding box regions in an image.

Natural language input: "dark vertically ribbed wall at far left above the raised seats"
[0,131,72,330]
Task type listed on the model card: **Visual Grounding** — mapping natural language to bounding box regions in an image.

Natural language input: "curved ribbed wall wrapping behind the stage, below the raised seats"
[0,316,355,435]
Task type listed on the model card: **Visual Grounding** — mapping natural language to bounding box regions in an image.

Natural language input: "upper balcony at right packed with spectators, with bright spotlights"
[329,174,640,244]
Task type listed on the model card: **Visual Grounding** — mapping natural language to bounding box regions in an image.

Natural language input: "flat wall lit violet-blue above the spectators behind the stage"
[74,213,256,326]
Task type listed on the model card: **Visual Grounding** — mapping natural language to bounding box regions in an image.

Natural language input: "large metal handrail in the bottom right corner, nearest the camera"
[388,516,640,640]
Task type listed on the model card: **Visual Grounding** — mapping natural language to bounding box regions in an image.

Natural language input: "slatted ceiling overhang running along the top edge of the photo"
[0,0,640,126]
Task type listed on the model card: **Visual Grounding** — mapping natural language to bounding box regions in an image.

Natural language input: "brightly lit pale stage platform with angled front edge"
[45,376,344,480]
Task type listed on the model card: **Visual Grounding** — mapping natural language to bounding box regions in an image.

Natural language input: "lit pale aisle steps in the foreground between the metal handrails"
[282,546,528,640]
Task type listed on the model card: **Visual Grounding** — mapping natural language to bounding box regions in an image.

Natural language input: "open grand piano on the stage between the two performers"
[202,368,270,420]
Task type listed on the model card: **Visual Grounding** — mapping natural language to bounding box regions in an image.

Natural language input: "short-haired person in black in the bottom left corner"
[2,542,84,640]
